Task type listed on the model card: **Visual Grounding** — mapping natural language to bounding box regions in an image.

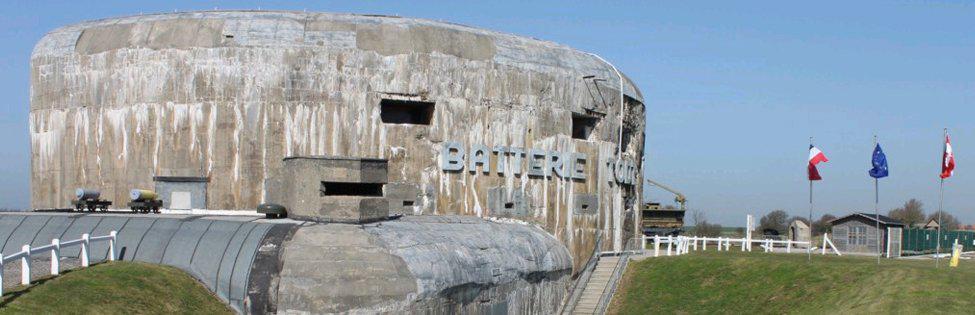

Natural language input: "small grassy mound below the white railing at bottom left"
[0,262,232,314]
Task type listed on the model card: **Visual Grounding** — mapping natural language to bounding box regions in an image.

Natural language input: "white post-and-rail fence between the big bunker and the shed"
[642,234,842,257]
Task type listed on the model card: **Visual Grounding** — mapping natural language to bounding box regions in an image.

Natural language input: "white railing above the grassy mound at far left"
[0,231,118,295]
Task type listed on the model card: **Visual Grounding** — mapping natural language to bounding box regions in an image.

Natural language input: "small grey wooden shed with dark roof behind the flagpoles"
[830,212,904,257]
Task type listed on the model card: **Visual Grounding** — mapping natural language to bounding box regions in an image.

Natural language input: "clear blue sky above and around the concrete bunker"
[0,0,975,225]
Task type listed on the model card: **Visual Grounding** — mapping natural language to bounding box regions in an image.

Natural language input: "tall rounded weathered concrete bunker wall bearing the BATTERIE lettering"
[29,12,644,272]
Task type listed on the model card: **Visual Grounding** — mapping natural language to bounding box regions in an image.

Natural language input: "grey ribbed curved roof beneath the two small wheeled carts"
[0,213,296,311]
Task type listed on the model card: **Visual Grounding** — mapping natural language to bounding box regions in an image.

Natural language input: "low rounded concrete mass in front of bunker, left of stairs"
[277,216,572,314]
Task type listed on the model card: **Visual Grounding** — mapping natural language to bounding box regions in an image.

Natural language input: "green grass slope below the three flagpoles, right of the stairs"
[610,251,975,314]
